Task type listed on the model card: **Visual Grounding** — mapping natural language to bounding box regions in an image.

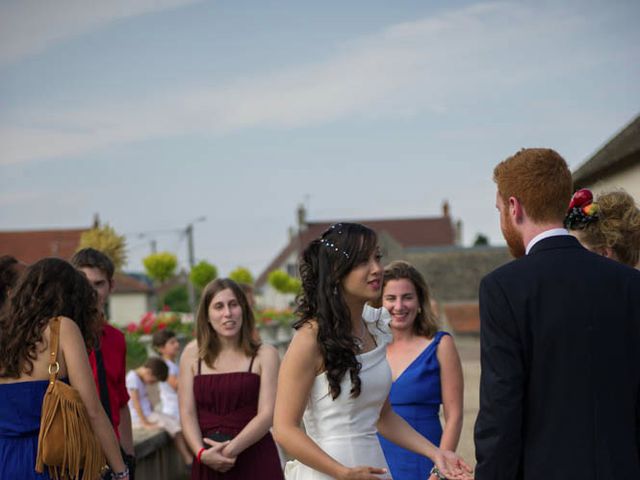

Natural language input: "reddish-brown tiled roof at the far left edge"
[0,228,88,264]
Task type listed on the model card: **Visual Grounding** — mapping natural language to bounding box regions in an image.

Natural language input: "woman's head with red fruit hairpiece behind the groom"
[565,188,640,267]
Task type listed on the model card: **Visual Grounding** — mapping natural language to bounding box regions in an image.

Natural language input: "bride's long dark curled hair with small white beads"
[293,223,378,399]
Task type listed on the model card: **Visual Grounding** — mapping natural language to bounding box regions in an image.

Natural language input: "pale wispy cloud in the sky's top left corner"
[0,0,200,66]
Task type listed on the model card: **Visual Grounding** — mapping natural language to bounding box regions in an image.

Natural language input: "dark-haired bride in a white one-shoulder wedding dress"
[273,223,472,480]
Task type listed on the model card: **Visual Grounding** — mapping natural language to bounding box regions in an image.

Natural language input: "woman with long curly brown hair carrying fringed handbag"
[0,258,128,480]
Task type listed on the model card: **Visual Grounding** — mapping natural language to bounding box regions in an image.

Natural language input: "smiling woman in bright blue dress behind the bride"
[380,261,463,480]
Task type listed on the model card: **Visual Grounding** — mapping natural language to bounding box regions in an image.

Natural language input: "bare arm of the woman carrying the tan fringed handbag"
[60,317,125,472]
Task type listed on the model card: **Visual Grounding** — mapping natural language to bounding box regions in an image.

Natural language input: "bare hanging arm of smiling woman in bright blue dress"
[437,335,464,451]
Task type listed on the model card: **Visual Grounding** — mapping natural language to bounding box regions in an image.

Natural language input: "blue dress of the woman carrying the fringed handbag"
[0,380,49,480]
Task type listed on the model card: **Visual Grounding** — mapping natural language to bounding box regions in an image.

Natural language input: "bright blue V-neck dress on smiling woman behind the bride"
[378,332,449,480]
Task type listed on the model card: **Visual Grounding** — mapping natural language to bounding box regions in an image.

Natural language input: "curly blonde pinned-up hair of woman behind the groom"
[577,190,640,267]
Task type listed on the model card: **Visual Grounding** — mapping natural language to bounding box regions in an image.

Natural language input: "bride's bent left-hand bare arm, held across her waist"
[273,325,386,480]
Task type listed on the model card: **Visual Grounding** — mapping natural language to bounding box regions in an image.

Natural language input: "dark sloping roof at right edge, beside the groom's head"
[573,115,640,188]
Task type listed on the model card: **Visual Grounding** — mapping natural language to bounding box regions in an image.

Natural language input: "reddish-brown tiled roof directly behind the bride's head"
[256,216,455,287]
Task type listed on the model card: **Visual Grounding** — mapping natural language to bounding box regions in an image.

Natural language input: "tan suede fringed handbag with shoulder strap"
[36,317,106,480]
